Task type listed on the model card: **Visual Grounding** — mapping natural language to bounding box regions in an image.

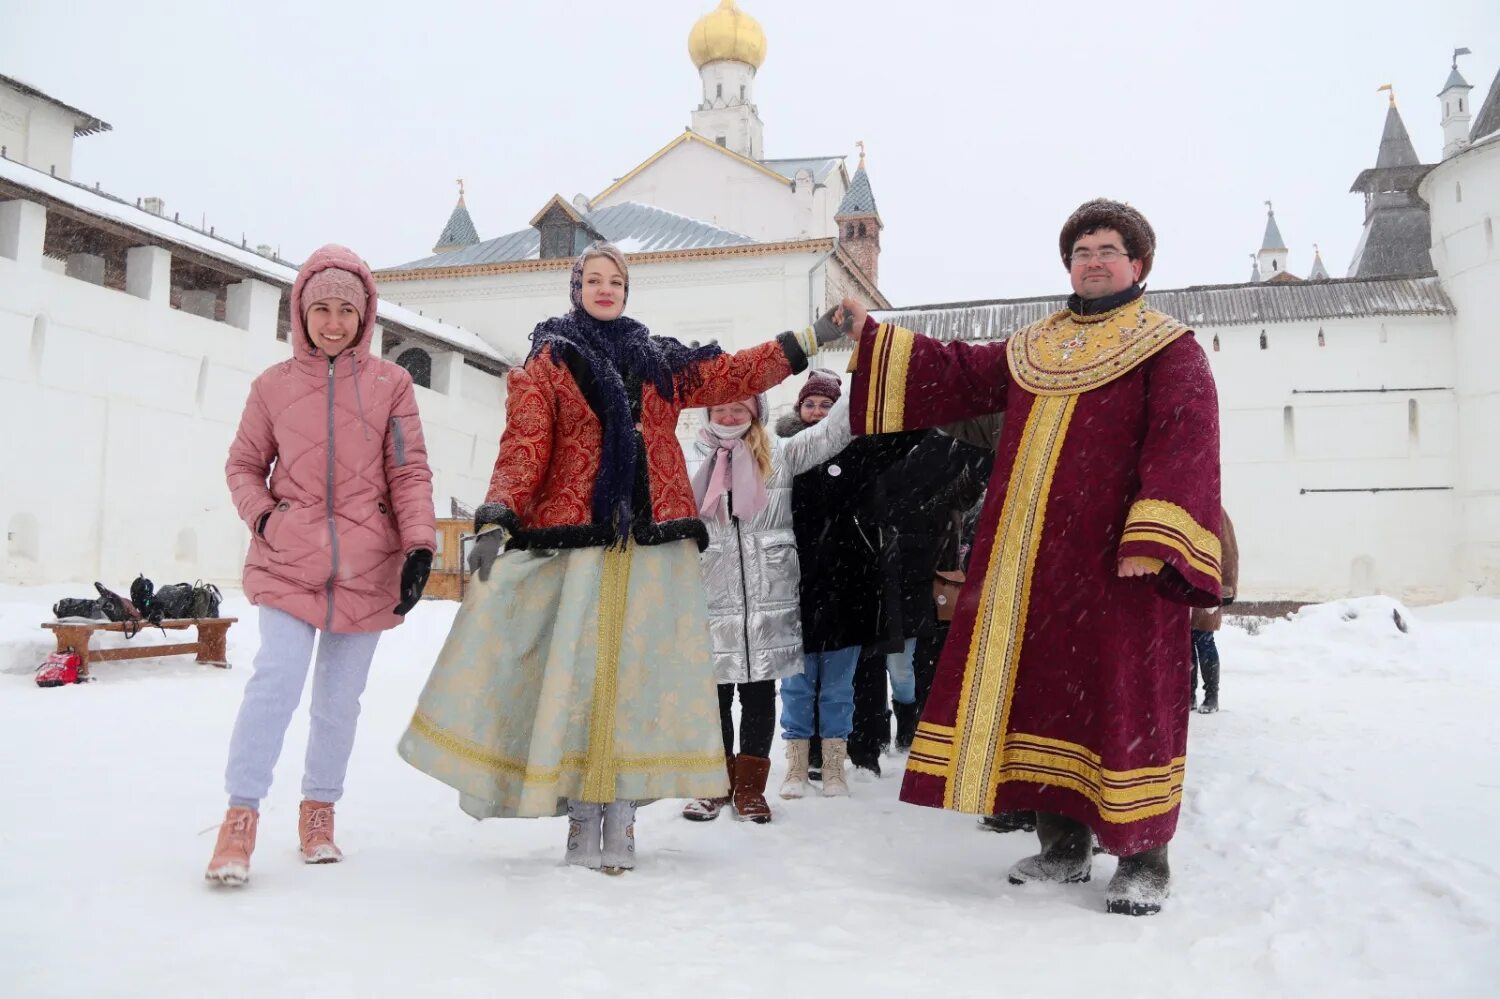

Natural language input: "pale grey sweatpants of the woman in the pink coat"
[224,608,380,809]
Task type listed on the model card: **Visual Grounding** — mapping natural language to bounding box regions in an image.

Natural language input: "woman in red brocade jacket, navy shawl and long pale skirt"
[399,243,840,873]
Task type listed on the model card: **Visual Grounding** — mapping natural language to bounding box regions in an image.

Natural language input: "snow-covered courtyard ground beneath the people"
[0,587,1500,999]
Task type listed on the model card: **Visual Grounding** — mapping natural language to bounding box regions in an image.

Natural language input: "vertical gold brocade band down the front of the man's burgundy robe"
[944,396,1079,813]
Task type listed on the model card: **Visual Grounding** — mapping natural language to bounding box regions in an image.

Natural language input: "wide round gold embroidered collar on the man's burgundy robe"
[1005,299,1191,396]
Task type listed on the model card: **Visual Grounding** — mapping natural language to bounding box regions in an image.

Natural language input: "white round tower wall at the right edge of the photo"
[1419,140,1500,596]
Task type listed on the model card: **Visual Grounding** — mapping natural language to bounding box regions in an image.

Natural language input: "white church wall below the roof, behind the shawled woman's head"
[381,244,842,437]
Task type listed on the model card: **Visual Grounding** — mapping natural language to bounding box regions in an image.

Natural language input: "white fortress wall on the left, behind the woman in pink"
[0,203,503,593]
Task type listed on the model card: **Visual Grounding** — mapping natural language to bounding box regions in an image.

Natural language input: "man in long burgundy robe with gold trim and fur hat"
[836,201,1221,915]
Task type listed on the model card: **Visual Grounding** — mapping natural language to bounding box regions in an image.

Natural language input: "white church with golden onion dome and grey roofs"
[375,0,890,420]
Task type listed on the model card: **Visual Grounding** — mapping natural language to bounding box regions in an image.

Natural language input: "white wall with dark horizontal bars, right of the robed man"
[1199,317,1458,603]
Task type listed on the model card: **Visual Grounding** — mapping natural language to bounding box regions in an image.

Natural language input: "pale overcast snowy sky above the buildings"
[0,0,1500,306]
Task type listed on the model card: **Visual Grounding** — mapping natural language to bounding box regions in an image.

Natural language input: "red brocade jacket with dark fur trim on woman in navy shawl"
[474,333,807,549]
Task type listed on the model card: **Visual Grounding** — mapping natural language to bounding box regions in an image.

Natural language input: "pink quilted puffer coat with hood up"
[225,246,437,632]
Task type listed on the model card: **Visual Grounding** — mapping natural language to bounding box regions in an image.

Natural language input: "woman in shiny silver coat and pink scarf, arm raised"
[683,384,854,822]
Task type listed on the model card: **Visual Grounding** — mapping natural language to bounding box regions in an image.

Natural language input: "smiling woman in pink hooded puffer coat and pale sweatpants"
[207,246,437,885]
